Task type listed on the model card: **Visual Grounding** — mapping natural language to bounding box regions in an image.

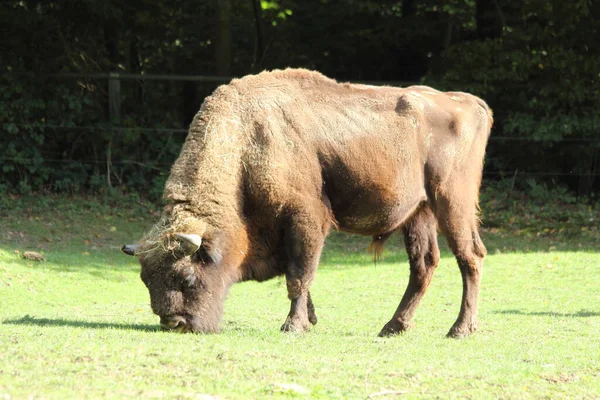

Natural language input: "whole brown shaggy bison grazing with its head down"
[122,69,492,337]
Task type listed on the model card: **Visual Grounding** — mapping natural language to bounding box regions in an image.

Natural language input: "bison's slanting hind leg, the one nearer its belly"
[379,206,440,336]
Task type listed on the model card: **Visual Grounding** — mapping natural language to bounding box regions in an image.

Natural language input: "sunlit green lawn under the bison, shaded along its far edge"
[0,197,600,399]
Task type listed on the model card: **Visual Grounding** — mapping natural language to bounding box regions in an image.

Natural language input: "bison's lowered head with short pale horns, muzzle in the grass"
[122,233,233,333]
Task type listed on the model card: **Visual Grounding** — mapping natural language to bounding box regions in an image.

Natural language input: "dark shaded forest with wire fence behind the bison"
[0,0,600,199]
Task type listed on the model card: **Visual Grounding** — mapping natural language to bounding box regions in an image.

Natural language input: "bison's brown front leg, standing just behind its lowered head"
[281,208,328,332]
